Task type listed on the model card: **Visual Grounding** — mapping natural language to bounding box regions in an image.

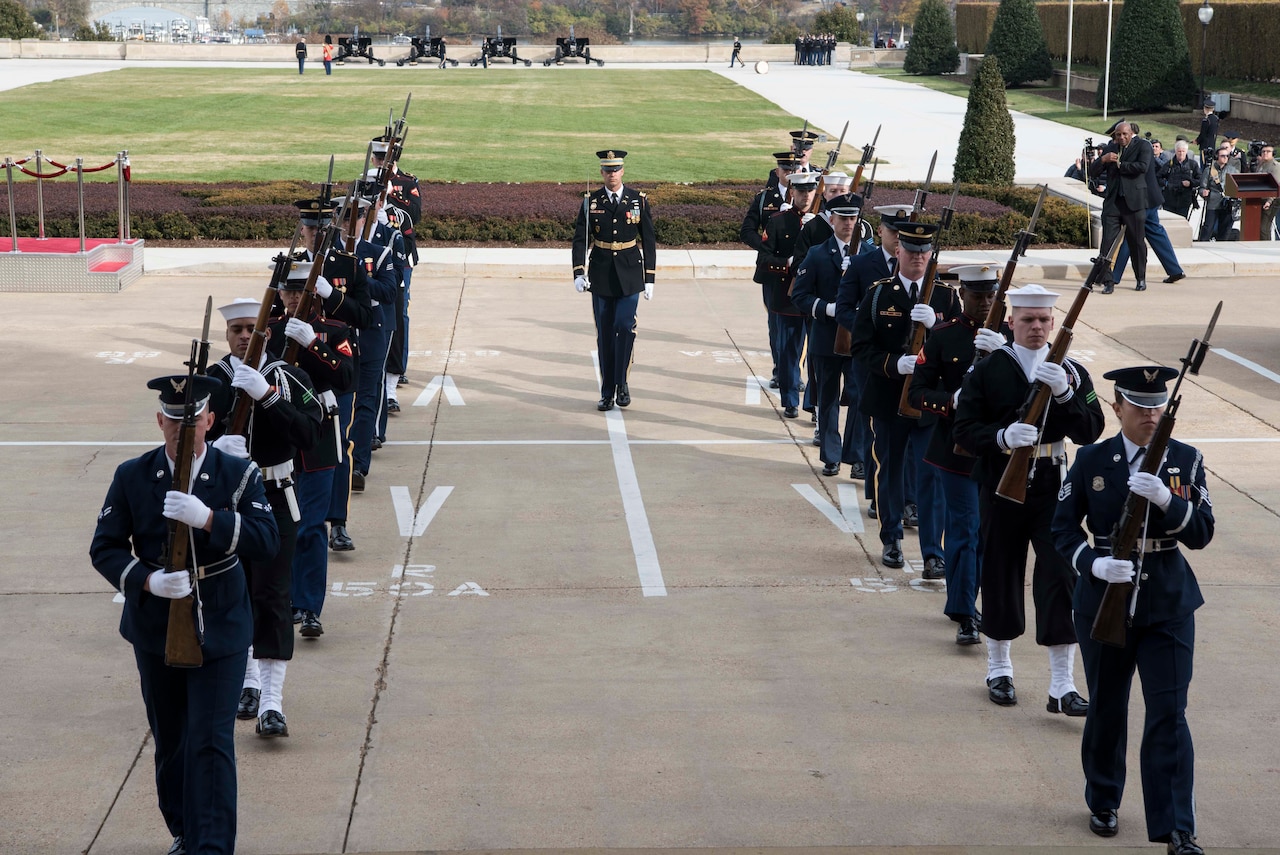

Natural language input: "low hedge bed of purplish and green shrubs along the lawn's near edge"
[0,182,1089,247]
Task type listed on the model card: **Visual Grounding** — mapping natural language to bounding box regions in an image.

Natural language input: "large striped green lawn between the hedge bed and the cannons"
[0,67,808,183]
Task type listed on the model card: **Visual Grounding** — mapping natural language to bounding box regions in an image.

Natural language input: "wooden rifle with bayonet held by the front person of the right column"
[1089,301,1222,648]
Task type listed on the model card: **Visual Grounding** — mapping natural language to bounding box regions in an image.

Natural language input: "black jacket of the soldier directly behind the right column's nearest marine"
[850,275,959,425]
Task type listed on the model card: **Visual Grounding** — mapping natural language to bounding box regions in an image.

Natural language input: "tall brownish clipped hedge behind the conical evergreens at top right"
[956,0,1280,82]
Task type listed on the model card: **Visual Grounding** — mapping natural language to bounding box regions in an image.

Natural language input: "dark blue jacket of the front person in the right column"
[1053,434,1213,626]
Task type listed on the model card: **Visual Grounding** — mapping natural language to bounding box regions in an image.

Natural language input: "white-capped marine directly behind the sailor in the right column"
[911,265,1005,644]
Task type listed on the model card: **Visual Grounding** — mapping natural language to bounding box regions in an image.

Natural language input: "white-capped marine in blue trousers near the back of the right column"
[754,169,818,419]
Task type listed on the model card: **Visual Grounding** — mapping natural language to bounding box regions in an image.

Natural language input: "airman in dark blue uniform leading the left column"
[90,374,279,855]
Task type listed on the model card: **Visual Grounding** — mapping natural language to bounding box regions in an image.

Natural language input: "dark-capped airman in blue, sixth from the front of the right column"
[791,193,863,475]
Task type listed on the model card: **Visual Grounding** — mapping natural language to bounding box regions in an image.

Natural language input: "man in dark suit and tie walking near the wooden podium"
[1089,122,1153,294]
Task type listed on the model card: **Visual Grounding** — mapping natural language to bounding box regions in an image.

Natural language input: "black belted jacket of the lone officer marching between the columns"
[573,186,657,298]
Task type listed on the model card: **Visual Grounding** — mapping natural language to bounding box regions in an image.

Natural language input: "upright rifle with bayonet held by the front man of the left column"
[164,297,214,668]
